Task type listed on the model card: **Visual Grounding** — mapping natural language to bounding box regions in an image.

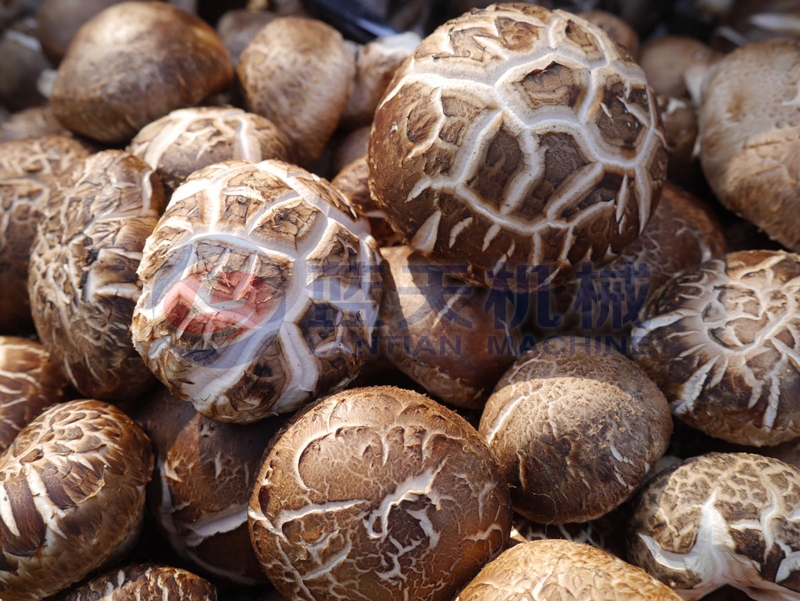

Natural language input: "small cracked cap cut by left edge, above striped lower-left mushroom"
[0,336,67,452]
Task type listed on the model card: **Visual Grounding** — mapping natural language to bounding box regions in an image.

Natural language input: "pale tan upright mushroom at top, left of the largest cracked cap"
[236,17,356,165]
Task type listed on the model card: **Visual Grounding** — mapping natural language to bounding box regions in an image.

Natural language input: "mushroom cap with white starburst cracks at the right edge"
[633,250,800,446]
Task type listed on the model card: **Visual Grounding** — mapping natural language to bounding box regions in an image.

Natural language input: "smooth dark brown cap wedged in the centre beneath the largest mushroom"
[379,246,518,409]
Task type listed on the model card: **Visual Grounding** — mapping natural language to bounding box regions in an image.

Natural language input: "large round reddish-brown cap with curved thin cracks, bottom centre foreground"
[249,386,511,601]
